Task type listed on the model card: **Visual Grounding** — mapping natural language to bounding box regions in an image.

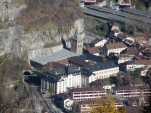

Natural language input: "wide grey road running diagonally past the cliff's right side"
[83,6,151,27]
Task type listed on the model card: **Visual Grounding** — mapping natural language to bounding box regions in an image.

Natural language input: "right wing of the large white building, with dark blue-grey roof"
[71,54,119,83]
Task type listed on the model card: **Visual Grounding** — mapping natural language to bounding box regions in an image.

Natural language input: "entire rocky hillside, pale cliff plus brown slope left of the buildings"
[0,0,84,113]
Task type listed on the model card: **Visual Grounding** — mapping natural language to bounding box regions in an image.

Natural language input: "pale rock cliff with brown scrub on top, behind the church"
[0,0,84,57]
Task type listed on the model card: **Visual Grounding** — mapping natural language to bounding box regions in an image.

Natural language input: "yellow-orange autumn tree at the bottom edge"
[91,97,126,113]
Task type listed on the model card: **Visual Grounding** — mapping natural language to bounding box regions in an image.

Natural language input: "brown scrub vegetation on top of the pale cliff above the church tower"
[17,0,81,32]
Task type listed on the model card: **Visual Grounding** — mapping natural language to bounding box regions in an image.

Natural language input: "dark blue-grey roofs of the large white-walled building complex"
[40,55,118,81]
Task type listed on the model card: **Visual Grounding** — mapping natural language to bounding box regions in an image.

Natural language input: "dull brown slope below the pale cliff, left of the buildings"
[0,55,32,113]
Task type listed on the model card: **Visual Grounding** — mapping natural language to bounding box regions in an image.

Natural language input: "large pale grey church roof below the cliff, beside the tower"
[31,49,77,65]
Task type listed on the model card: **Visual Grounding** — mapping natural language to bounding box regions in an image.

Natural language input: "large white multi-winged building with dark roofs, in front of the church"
[41,55,119,94]
